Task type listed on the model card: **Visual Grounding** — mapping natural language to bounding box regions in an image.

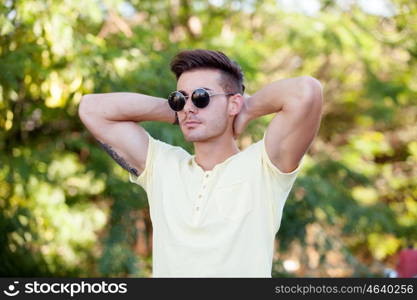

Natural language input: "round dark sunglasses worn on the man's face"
[168,88,237,111]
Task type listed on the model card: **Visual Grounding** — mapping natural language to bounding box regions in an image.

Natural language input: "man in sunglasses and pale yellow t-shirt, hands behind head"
[79,49,322,277]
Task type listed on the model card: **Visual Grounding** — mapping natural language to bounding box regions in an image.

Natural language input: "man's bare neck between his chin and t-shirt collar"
[194,135,240,171]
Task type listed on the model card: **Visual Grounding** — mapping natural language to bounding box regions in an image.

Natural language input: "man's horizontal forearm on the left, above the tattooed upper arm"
[79,93,175,123]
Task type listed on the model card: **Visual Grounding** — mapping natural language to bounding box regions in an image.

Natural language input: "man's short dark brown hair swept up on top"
[171,49,245,95]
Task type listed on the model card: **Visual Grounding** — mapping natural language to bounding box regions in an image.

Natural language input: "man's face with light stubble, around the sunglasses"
[177,69,233,142]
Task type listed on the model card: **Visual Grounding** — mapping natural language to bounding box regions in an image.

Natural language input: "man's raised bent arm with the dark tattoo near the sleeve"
[78,93,175,176]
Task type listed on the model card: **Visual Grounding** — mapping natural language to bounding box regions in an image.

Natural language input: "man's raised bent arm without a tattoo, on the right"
[234,76,323,172]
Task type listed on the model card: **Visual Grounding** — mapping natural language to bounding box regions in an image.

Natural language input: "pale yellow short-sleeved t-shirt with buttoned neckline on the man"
[130,135,302,277]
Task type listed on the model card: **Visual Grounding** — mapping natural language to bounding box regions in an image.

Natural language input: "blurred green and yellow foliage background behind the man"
[0,0,417,276]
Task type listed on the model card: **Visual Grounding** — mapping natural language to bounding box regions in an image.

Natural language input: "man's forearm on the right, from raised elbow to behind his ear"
[246,76,321,120]
